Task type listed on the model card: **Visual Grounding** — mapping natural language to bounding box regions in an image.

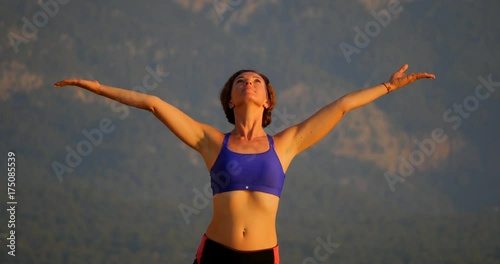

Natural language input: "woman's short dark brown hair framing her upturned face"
[220,70,276,127]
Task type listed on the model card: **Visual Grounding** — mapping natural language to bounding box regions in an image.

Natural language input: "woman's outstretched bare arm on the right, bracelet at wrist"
[276,64,435,159]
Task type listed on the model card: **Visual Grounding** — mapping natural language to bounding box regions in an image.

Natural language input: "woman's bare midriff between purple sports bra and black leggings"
[206,191,279,251]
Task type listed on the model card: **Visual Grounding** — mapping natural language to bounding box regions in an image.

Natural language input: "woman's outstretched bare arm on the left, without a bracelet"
[54,79,222,155]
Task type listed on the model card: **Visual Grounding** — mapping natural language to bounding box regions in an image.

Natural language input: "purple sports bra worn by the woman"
[210,133,285,197]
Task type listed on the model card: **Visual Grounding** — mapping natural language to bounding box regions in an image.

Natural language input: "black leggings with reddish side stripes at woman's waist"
[193,235,280,264]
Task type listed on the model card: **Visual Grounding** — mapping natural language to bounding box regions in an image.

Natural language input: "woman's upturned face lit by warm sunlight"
[230,72,268,108]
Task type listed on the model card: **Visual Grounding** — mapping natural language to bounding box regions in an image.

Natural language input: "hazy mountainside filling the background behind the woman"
[0,0,500,263]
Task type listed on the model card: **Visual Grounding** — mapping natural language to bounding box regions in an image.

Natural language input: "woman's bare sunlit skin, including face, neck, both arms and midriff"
[55,64,435,251]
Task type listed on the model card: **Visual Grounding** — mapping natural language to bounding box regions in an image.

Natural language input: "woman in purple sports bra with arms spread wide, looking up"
[55,64,435,264]
